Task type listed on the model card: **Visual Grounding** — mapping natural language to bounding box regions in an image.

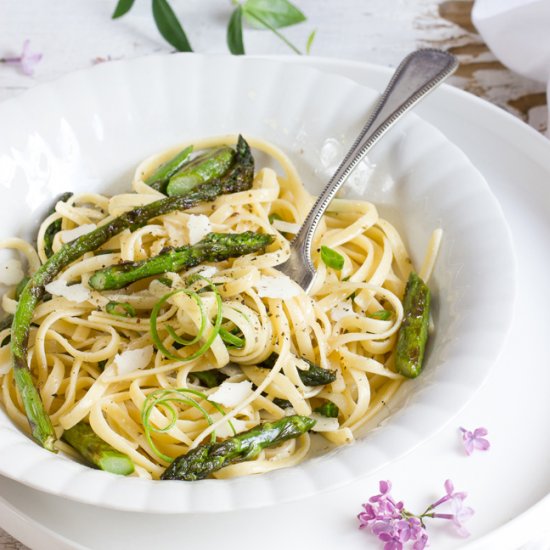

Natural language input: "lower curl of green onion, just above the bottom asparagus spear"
[141,388,237,463]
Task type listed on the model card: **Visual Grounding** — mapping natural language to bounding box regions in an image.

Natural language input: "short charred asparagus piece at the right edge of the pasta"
[395,272,430,378]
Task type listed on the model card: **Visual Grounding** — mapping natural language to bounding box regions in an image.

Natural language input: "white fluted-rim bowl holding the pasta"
[0,55,515,513]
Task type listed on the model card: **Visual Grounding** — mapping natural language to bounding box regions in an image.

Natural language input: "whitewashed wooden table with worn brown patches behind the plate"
[0,0,547,550]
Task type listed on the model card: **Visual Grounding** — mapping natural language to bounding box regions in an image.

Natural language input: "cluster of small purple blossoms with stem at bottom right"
[357,479,474,550]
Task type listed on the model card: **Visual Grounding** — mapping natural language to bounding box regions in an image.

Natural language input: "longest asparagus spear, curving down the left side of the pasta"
[11,136,254,451]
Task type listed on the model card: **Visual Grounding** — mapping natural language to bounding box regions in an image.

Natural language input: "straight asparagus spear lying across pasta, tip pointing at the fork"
[88,231,273,290]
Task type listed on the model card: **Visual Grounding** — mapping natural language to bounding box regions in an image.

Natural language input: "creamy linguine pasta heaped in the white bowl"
[0,137,440,479]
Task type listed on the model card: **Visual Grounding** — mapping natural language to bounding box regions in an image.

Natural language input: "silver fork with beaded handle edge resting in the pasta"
[277,49,458,292]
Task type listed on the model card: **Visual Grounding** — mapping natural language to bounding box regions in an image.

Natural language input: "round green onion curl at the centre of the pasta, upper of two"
[150,275,223,361]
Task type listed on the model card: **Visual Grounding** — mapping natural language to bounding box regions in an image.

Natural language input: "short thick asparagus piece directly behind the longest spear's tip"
[166,147,235,197]
